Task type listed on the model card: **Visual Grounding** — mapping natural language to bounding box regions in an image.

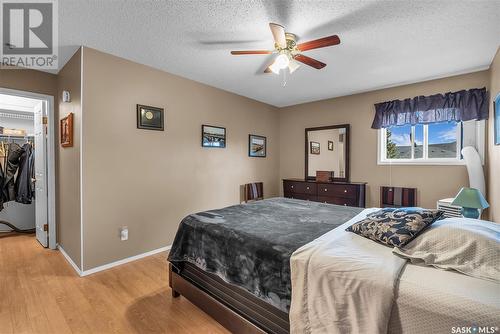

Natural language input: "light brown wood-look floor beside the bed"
[0,234,227,334]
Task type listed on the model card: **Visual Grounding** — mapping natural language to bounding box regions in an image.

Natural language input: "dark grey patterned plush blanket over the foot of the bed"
[168,198,362,312]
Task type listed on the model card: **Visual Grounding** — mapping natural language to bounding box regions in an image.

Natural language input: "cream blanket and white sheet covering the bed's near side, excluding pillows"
[290,208,500,334]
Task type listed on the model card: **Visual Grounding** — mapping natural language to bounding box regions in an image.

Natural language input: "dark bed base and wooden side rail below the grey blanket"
[169,263,290,334]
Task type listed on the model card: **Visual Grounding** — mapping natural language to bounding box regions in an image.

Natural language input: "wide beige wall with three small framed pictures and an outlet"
[82,48,280,270]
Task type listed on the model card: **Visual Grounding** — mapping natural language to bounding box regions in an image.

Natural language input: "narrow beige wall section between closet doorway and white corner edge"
[56,50,82,268]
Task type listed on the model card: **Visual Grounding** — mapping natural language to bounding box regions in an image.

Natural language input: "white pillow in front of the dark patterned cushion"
[393,218,500,282]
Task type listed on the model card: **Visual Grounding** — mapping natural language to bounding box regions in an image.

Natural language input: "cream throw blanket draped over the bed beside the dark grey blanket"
[290,209,405,334]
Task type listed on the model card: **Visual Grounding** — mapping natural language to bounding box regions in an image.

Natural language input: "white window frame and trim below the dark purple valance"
[377,120,486,166]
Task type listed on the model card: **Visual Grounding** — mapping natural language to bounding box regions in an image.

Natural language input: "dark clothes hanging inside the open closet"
[0,143,35,211]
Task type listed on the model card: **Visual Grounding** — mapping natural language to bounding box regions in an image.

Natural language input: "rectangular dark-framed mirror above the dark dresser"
[305,124,350,182]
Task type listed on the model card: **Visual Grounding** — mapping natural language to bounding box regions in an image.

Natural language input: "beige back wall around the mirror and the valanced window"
[280,71,489,207]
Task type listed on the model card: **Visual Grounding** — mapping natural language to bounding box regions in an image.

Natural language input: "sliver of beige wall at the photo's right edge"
[487,48,500,223]
